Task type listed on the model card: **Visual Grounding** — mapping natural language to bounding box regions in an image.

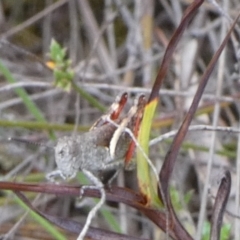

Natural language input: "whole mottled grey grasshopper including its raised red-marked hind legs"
[47,93,146,181]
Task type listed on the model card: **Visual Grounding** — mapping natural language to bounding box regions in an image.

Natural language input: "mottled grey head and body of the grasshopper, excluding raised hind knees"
[50,123,128,179]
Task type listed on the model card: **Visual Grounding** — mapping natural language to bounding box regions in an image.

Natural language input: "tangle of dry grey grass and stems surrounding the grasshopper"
[0,0,240,240]
